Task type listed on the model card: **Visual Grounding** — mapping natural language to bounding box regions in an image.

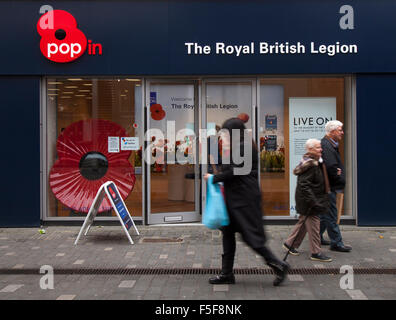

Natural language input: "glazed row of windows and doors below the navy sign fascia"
[42,76,354,223]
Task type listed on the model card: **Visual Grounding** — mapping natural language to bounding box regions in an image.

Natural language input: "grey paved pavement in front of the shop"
[0,224,396,301]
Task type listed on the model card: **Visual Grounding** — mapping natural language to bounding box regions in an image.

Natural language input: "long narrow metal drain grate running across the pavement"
[0,268,396,275]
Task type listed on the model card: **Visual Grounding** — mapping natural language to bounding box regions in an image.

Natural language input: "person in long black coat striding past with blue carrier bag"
[204,118,289,286]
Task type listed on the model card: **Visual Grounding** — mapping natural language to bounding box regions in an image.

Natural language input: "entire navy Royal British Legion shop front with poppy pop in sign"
[0,0,396,227]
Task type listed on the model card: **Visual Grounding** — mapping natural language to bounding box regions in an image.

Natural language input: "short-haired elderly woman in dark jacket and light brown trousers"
[283,139,332,262]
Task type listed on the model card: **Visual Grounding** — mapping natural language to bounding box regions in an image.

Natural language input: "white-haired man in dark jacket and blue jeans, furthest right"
[320,120,352,252]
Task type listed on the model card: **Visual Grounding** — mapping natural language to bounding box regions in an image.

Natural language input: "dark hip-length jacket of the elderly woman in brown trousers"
[293,156,330,215]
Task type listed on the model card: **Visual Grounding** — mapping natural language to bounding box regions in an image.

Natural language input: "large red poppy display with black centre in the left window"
[49,119,136,212]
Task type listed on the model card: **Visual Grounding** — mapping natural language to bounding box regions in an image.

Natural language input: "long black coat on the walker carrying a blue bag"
[213,139,265,248]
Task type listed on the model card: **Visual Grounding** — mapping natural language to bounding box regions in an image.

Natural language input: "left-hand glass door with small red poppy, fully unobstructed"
[145,80,201,224]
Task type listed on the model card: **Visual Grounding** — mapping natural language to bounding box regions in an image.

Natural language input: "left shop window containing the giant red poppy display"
[46,78,142,217]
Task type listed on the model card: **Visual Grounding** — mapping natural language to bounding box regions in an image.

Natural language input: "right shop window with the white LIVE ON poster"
[258,77,352,216]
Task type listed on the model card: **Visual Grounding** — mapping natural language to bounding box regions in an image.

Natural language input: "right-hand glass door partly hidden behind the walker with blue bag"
[202,79,257,208]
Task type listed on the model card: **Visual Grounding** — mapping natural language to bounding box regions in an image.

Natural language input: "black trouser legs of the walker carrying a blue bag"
[221,227,280,274]
